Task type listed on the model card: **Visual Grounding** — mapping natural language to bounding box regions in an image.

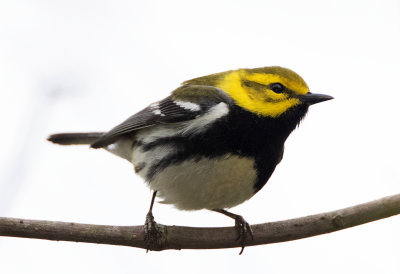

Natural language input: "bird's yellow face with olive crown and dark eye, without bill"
[216,67,309,117]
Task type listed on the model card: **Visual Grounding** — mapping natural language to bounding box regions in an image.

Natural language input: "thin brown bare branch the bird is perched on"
[0,194,400,250]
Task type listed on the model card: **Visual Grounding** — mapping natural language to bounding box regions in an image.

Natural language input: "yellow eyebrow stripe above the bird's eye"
[244,73,309,95]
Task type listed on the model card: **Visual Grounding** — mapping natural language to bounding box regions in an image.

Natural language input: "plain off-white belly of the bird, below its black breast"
[144,154,257,210]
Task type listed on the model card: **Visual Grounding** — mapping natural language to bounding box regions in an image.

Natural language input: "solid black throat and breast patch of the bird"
[206,105,308,192]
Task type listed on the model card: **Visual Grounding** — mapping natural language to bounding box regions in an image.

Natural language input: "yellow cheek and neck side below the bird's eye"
[216,70,302,117]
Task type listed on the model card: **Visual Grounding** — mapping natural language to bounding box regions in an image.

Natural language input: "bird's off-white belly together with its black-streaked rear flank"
[133,139,257,210]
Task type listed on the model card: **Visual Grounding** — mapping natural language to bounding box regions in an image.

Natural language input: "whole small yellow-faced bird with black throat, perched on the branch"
[48,66,333,252]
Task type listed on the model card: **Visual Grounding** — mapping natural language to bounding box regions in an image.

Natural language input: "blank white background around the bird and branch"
[0,0,400,274]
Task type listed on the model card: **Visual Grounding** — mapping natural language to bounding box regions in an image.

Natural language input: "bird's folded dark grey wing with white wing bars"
[91,85,232,148]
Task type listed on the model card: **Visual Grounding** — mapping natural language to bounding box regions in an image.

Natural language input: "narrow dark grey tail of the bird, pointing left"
[47,132,104,145]
